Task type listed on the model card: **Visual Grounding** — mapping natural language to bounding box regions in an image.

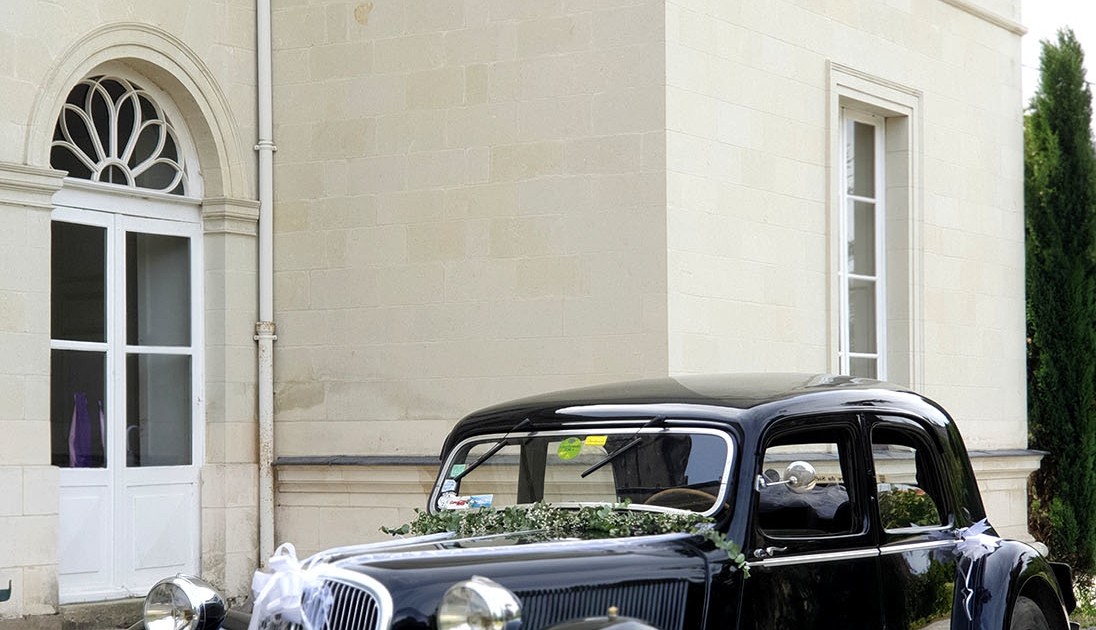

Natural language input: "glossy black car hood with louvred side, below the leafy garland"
[319,532,707,630]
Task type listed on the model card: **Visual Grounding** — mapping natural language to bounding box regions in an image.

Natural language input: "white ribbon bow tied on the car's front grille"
[248,542,334,630]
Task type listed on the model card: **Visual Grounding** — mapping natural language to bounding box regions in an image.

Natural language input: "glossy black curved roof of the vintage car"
[443,374,947,451]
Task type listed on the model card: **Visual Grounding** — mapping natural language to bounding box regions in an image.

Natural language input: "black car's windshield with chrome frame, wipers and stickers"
[431,427,732,514]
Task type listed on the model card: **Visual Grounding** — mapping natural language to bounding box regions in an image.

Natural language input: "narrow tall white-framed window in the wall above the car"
[838,110,887,379]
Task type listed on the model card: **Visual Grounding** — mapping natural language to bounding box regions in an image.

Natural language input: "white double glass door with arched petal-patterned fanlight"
[49,68,204,603]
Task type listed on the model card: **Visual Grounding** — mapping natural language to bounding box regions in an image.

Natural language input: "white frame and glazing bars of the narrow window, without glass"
[837,107,887,380]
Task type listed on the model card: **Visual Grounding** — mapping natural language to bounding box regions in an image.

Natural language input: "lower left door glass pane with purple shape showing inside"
[49,350,106,468]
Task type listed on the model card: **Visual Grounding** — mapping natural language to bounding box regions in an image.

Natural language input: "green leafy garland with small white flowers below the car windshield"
[380,502,750,576]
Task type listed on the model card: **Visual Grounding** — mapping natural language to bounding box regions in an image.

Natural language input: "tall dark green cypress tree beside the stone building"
[1024,30,1096,572]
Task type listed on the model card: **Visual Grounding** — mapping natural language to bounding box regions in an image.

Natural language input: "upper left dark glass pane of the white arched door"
[49,221,106,342]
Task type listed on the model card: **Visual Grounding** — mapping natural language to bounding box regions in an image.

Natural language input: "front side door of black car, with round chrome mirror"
[742,414,883,630]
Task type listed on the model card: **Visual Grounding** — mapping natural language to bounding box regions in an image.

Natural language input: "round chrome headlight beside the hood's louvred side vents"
[437,575,522,630]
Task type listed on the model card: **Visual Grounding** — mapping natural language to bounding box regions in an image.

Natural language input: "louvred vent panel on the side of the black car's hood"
[515,581,688,630]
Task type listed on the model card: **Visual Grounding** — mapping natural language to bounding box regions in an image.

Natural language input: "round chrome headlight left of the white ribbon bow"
[145,575,225,630]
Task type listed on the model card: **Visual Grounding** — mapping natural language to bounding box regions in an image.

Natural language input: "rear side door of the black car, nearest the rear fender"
[865,416,968,630]
